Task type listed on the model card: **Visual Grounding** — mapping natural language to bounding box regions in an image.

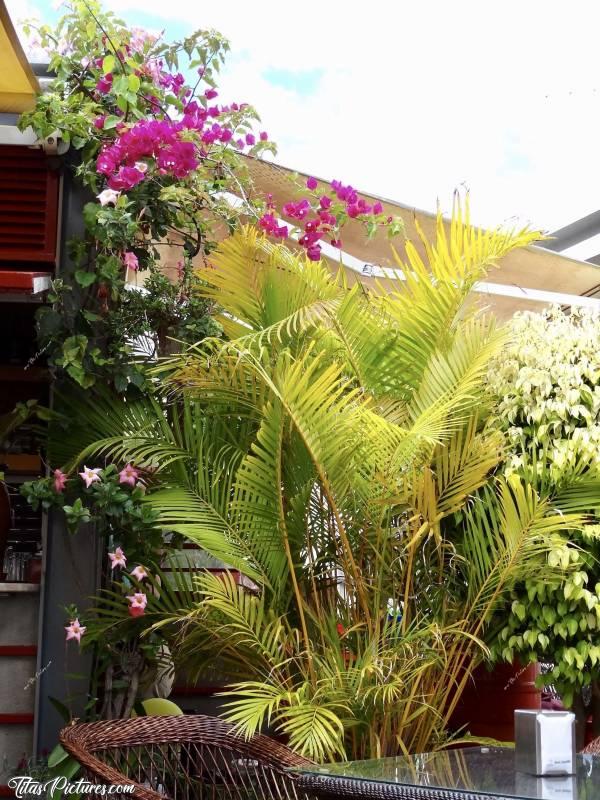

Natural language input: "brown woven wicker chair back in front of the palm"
[60,715,310,800]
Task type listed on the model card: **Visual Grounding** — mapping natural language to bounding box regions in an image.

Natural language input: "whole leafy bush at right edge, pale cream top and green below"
[489,309,600,733]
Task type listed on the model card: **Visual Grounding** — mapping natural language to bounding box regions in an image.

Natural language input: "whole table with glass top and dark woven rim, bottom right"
[294,747,600,800]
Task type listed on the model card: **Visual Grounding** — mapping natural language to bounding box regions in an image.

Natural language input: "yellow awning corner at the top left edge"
[0,0,40,114]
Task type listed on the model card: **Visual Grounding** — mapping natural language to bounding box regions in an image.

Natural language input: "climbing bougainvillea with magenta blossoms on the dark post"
[20,0,399,391]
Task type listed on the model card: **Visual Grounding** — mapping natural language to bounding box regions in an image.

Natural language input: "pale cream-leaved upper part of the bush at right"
[489,308,600,481]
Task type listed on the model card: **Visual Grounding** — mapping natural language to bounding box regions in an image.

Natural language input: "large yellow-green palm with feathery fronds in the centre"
[65,201,579,760]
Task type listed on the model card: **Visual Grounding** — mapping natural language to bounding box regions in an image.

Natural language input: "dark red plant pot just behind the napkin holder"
[451,663,542,742]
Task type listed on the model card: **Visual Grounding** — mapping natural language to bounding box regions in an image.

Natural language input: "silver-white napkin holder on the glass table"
[515,711,576,775]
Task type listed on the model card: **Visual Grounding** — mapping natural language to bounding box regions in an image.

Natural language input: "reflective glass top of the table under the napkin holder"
[294,747,600,800]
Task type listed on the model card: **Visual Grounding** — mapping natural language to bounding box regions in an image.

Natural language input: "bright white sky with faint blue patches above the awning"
[8,0,600,255]
